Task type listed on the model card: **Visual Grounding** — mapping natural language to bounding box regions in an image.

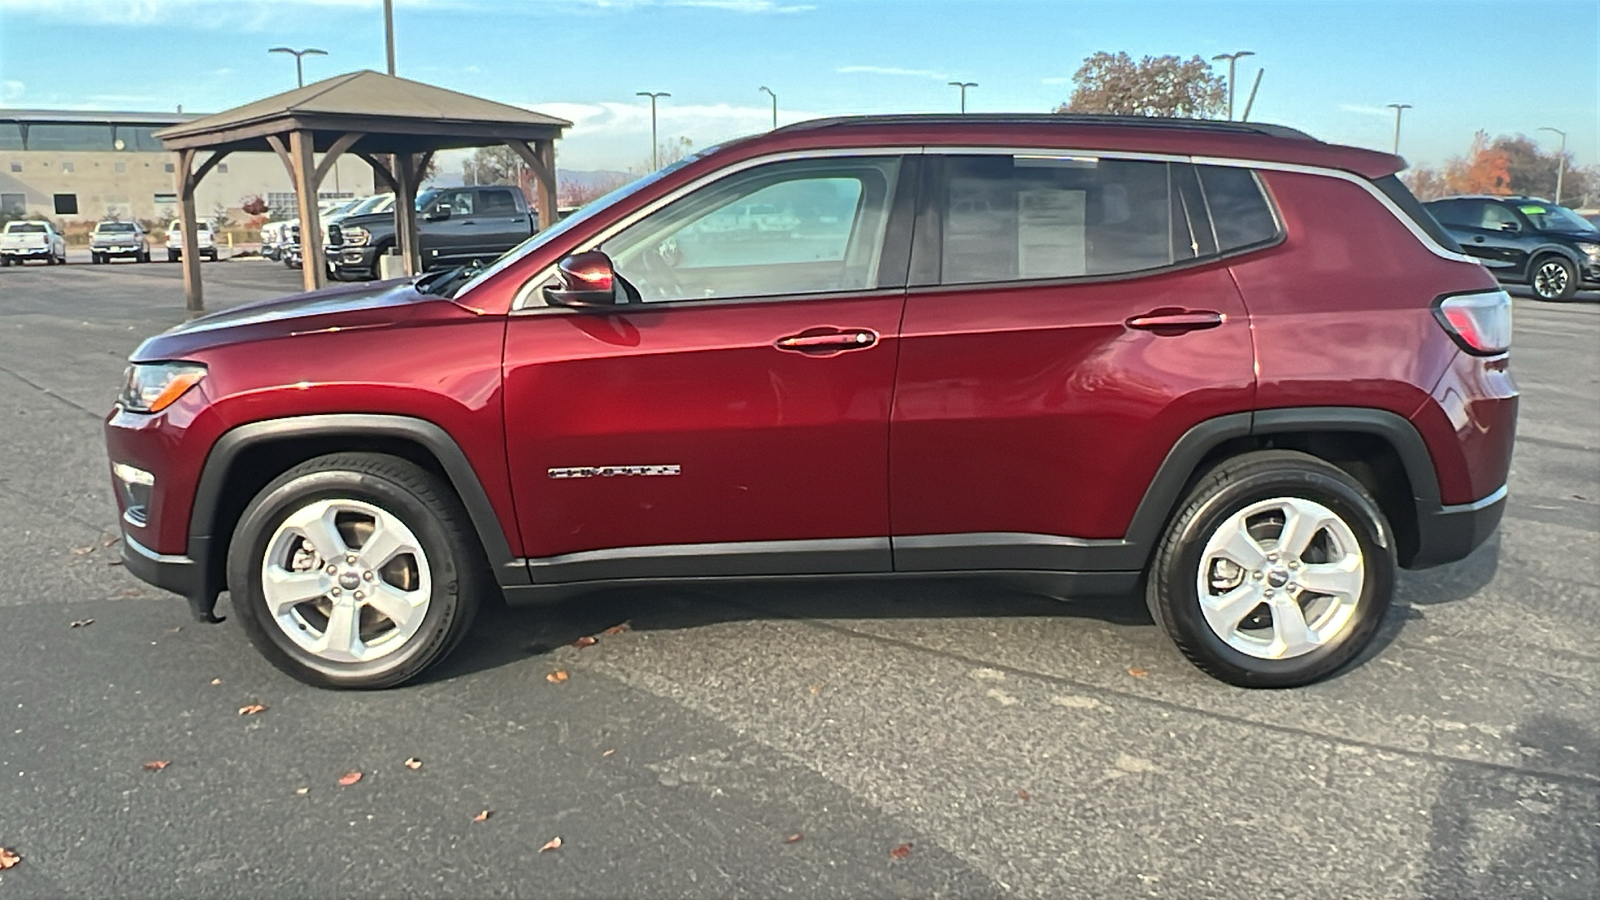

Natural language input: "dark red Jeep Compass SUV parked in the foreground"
[106,115,1517,687]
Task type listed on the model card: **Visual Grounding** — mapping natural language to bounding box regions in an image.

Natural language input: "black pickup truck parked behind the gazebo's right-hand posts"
[328,184,538,280]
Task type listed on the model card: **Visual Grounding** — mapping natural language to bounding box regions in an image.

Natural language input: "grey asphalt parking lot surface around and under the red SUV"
[0,259,1600,900]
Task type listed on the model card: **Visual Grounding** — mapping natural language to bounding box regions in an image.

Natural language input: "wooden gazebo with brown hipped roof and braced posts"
[155,70,573,315]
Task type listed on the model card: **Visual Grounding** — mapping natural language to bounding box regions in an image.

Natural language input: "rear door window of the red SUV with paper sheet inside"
[939,155,1195,285]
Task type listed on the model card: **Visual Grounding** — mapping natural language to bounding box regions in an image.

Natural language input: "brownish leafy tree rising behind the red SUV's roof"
[1056,51,1227,119]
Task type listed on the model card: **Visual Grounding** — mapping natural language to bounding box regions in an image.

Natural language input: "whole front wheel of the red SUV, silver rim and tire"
[227,453,486,689]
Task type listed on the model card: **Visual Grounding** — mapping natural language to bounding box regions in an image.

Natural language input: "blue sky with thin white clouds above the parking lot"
[0,0,1600,168]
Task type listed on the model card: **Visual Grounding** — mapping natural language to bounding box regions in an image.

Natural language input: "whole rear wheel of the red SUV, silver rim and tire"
[1146,450,1395,687]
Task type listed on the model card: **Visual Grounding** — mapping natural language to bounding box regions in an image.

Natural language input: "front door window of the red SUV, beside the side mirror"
[600,157,899,303]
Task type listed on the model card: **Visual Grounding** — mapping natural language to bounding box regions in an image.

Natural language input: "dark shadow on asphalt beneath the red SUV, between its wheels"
[418,578,1154,684]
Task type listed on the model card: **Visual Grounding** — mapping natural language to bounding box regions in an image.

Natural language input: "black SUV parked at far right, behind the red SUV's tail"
[1424,195,1600,299]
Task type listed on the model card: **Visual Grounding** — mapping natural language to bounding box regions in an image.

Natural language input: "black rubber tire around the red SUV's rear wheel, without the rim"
[1146,450,1395,687]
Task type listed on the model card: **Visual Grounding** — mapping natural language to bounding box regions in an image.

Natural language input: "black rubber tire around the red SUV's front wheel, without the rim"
[227,453,493,689]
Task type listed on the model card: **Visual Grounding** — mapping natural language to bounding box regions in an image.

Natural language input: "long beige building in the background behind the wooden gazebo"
[0,109,373,226]
